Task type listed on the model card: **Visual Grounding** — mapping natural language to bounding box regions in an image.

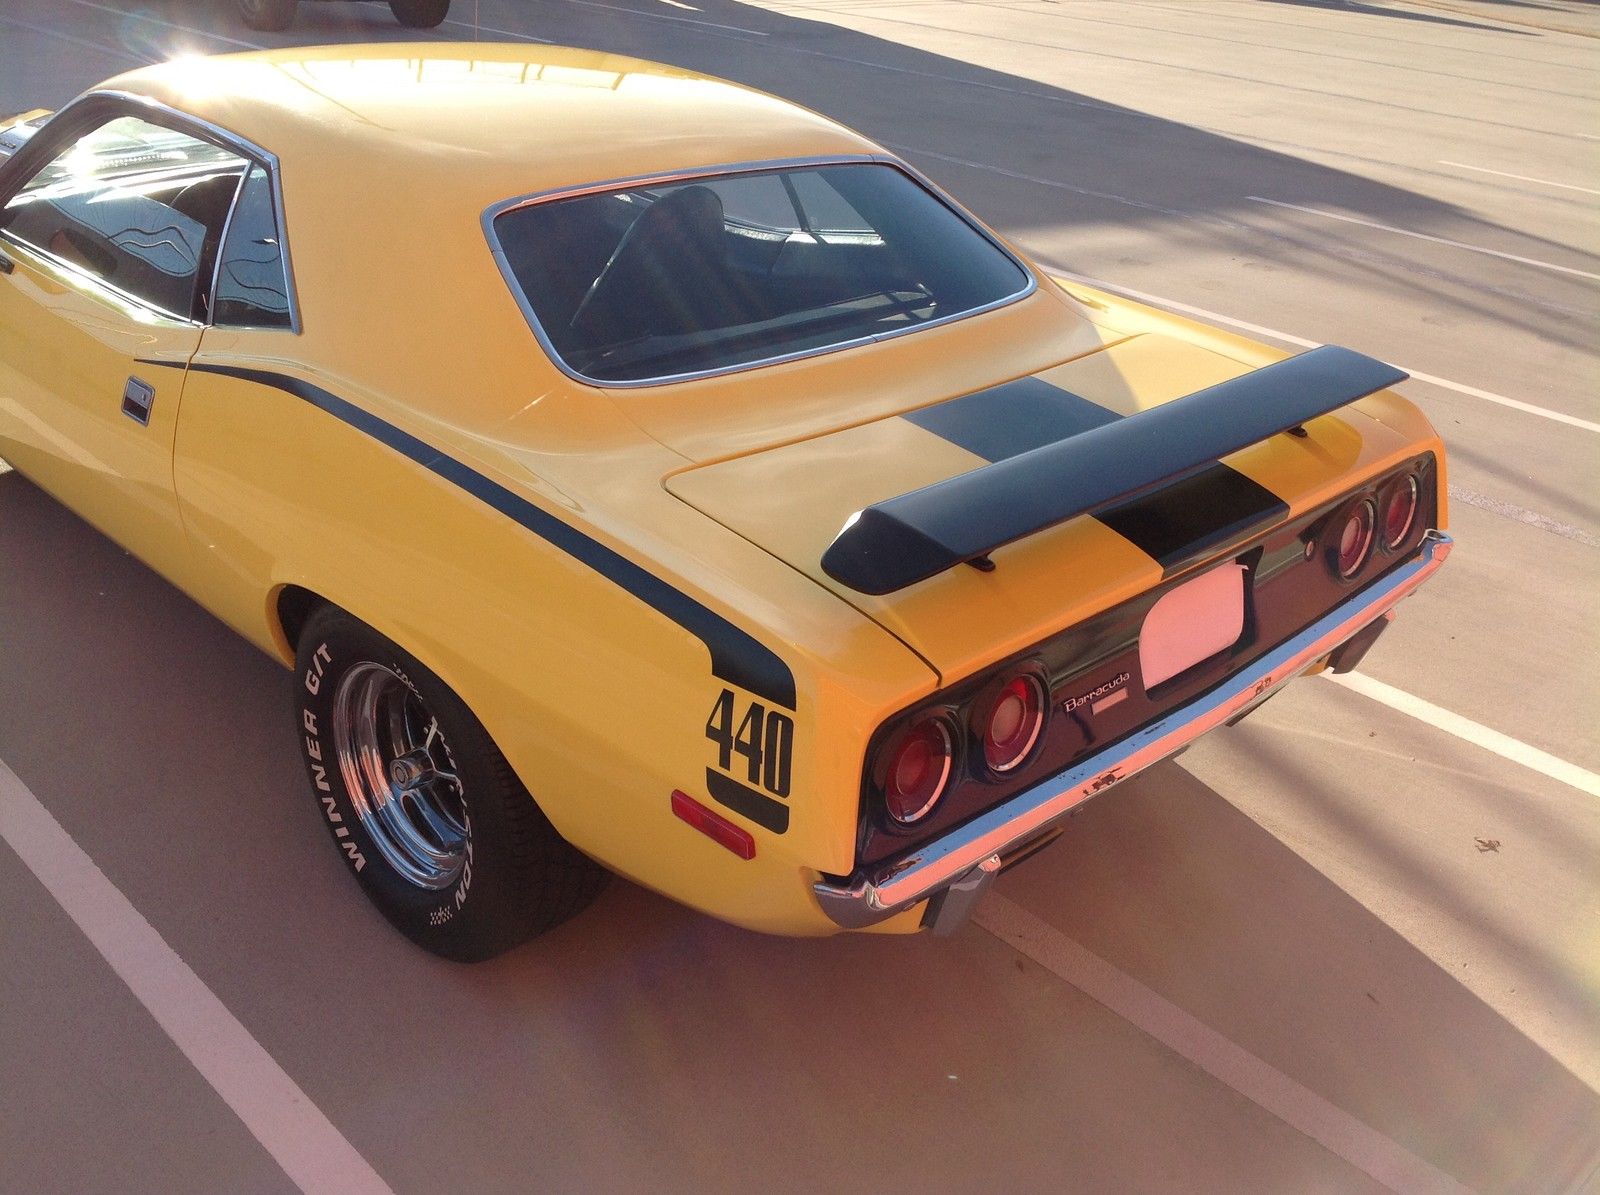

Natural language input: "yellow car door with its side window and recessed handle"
[0,98,251,576]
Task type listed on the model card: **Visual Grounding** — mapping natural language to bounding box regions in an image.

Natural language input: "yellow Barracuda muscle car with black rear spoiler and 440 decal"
[0,43,1450,958]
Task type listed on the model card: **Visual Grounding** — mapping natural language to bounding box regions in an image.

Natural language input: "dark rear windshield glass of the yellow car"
[494,163,1029,382]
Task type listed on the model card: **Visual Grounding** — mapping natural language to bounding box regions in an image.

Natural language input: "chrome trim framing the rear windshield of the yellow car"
[482,154,1038,390]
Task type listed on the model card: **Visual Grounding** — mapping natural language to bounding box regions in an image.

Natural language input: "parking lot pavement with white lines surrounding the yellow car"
[0,0,1600,1192]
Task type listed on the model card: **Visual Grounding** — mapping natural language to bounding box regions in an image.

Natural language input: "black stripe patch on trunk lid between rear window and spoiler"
[901,378,1122,461]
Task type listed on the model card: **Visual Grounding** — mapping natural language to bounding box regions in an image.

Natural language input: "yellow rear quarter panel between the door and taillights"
[176,331,933,933]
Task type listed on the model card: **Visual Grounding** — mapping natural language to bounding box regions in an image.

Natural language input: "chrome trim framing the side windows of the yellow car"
[0,90,301,336]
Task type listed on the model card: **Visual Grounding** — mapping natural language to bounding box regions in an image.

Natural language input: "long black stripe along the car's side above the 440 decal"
[184,362,795,710]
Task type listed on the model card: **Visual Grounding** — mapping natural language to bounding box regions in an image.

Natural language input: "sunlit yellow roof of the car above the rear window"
[96,42,882,210]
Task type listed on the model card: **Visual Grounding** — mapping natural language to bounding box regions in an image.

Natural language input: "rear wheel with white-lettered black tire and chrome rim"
[294,606,606,961]
